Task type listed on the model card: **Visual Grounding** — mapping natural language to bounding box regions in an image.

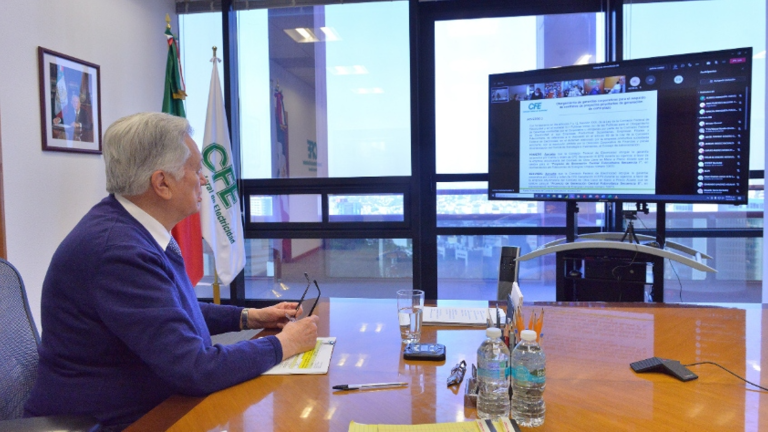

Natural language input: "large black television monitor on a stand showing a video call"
[488,48,752,204]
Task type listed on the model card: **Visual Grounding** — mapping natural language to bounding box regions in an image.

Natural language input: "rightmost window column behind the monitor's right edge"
[623,0,766,302]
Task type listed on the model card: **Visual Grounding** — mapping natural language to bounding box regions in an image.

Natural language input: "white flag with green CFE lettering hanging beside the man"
[200,54,245,284]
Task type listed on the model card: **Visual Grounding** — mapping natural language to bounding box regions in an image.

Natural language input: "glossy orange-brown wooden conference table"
[128,298,768,432]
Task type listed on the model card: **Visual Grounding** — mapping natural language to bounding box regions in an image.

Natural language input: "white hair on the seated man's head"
[103,112,192,196]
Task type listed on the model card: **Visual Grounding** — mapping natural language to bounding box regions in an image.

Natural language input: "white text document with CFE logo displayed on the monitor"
[520,91,657,194]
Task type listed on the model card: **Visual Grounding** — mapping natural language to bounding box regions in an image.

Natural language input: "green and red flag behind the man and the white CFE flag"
[163,15,203,286]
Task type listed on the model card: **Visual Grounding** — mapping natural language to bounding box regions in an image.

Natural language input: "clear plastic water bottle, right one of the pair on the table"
[511,330,546,427]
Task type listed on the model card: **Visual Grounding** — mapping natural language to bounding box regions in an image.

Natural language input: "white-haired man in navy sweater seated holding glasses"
[25,113,317,430]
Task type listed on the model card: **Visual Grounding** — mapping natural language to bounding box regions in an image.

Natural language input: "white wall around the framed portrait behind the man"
[0,0,176,327]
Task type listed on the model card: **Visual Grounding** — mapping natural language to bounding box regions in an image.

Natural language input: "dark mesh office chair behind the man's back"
[0,258,98,431]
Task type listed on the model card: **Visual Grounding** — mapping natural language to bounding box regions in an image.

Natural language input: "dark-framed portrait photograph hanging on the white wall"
[37,47,101,154]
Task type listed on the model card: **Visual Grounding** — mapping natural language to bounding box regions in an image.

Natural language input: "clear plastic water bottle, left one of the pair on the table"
[477,327,509,419]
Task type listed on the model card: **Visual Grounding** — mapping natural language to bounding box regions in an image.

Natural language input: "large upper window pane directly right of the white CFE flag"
[238,1,411,179]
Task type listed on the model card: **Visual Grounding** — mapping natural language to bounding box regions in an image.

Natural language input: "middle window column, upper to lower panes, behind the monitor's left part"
[434,12,605,300]
